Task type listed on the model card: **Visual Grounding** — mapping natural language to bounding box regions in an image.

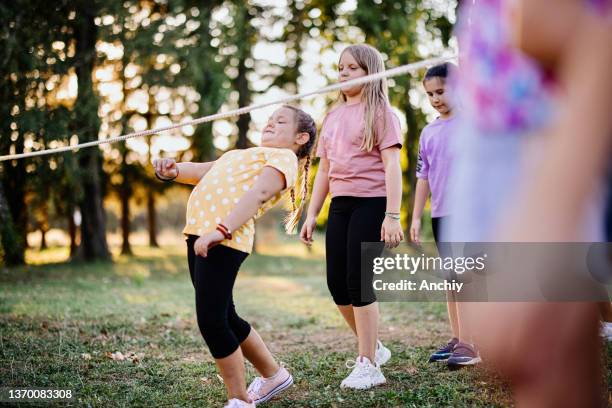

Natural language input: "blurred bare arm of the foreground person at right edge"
[505,9,612,242]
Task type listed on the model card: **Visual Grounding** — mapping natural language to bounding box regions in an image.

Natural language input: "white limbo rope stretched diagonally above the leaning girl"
[0,56,456,162]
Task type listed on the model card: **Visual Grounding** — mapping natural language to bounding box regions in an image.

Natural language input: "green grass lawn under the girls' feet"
[0,247,604,407]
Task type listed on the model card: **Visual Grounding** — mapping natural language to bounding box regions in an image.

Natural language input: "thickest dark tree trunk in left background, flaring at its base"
[74,3,111,261]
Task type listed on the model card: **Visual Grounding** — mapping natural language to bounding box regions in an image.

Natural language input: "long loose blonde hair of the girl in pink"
[339,44,389,152]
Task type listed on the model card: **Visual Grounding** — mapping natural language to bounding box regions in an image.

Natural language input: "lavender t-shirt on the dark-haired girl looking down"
[417,115,457,217]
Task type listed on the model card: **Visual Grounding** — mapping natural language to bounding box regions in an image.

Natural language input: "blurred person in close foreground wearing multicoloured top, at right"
[443,0,612,407]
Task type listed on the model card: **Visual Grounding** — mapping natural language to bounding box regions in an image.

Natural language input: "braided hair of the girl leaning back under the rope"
[283,105,317,234]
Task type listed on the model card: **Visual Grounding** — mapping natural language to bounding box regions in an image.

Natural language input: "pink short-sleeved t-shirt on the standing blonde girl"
[317,103,402,197]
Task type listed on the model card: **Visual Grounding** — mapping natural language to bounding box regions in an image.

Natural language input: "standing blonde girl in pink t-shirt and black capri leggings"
[300,45,404,389]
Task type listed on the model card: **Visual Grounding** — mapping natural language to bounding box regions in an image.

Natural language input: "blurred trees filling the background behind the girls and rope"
[0,0,457,265]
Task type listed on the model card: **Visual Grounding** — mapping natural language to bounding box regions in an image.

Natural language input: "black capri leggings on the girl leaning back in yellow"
[187,235,251,358]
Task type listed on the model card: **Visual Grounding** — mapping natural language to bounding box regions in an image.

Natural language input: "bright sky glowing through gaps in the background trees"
[32,0,456,161]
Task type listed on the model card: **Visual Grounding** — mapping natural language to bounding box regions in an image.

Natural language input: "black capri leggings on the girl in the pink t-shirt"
[325,196,387,307]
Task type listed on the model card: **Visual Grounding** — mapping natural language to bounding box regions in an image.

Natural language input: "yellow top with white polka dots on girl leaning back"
[183,147,298,253]
